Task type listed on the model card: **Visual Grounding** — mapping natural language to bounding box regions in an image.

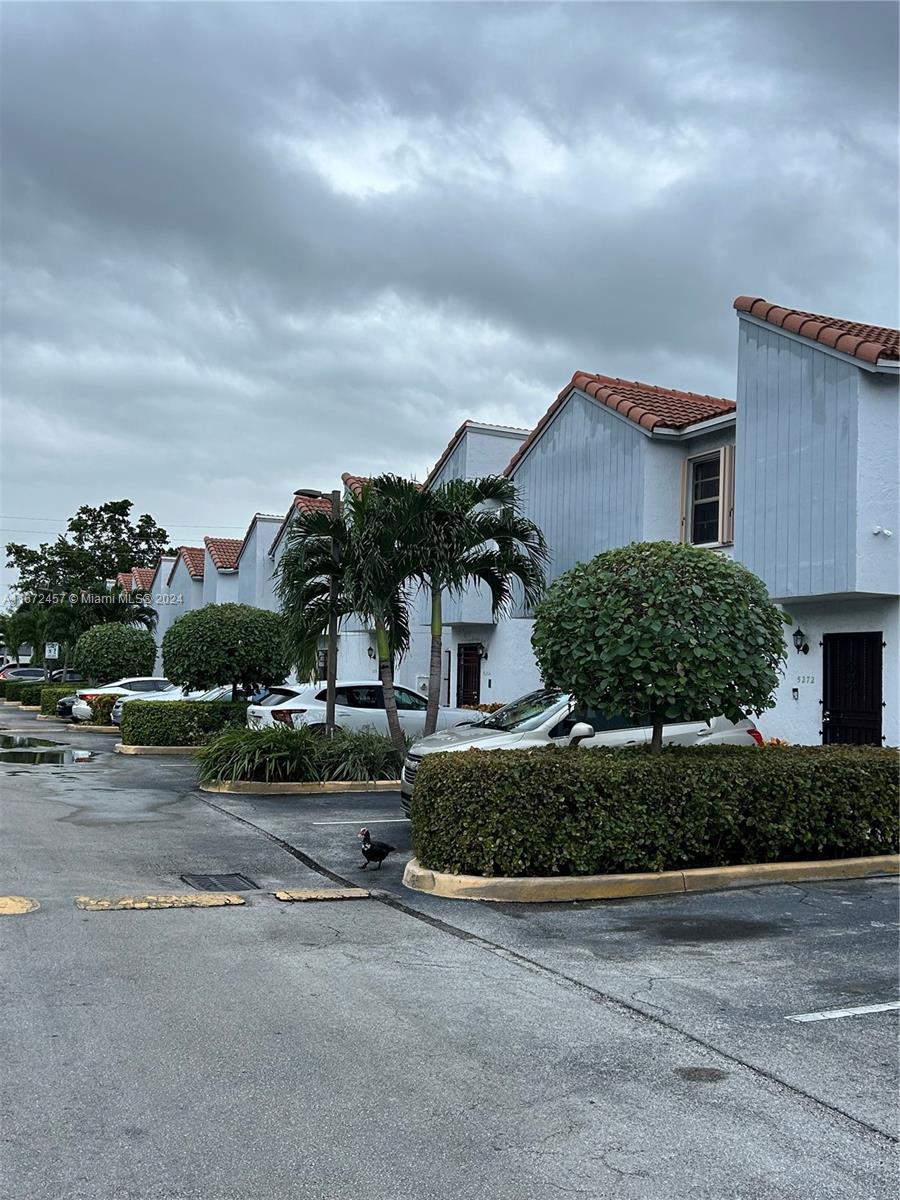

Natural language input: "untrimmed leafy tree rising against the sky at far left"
[6,500,169,593]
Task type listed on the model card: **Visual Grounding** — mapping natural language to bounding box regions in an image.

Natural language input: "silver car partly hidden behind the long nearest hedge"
[400,688,763,812]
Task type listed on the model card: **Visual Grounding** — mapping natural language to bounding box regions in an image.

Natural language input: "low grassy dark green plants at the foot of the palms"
[197,726,401,784]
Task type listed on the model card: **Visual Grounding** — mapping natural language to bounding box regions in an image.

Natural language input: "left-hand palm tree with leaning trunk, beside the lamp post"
[276,484,409,754]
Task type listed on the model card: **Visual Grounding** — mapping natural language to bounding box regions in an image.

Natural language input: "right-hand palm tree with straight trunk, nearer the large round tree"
[371,475,548,736]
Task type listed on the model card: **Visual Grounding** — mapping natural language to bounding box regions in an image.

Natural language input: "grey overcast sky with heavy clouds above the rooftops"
[0,2,898,585]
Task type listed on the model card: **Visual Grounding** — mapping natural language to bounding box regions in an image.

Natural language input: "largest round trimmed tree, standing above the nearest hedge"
[532,541,786,754]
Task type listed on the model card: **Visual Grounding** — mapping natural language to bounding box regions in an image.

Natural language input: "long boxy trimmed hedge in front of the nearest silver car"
[412,746,900,876]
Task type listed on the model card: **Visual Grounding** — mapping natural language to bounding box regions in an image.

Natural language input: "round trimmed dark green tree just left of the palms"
[162,604,290,700]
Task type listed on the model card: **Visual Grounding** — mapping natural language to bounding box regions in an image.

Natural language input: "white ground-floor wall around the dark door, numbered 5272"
[757,598,900,746]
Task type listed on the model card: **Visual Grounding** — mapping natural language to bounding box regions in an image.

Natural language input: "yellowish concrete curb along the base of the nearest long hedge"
[403,854,900,904]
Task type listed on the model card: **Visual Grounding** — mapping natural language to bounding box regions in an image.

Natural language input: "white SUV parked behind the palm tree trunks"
[247,679,472,738]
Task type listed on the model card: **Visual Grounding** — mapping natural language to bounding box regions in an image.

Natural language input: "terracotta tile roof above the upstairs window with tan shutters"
[505,371,736,475]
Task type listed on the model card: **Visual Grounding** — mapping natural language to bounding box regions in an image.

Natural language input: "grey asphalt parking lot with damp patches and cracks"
[0,712,899,1200]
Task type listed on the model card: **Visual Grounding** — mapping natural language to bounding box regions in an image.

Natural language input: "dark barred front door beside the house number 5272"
[822,634,882,745]
